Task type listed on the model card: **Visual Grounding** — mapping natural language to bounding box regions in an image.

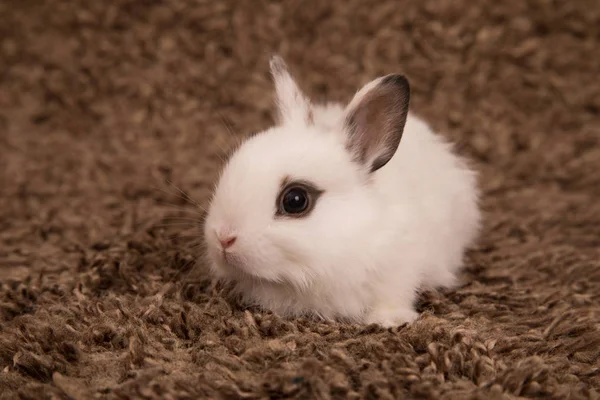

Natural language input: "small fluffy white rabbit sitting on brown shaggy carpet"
[204,56,481,326]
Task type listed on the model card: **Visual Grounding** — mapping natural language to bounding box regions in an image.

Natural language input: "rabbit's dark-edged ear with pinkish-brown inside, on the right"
[344,74,410,172]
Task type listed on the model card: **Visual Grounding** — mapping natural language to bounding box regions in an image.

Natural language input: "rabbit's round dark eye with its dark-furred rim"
[276,179,322,218]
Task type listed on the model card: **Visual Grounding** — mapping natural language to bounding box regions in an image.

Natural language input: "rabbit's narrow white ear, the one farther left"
[269,55,312,124]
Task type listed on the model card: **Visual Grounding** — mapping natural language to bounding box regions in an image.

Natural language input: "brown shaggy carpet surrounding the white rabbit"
[0,0,600,399]
